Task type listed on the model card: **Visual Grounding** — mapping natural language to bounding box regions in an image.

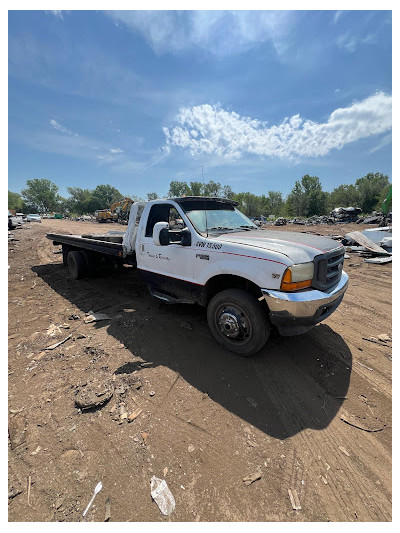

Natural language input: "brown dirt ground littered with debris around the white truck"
[8,216,392,522]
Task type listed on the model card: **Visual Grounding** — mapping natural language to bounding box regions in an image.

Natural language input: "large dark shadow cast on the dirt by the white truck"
[32,263,352,440]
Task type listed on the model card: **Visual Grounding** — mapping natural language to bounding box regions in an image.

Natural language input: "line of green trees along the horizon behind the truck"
[8,172,391,217]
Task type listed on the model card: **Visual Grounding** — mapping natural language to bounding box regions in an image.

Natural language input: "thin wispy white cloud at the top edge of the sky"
[106,11,295,57]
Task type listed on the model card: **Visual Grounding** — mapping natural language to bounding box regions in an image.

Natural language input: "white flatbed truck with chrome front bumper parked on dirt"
[47,196,348,356]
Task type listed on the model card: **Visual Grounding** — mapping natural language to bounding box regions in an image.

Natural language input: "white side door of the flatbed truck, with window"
[136,202,196,298]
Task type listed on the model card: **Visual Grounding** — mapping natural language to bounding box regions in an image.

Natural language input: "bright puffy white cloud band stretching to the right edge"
[163,92,392,160]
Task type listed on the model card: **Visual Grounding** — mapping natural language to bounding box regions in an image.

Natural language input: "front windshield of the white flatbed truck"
[185,204,257,233]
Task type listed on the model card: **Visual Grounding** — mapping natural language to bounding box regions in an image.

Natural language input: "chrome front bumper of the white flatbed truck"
[261,272,349,335]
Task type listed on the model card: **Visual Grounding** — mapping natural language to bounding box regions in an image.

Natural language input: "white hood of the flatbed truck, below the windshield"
[216,229,343,263]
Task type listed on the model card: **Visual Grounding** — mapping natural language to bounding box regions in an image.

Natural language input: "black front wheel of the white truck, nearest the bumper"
[207,289,271,357]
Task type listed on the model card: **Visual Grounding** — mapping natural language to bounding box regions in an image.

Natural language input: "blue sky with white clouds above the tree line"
[8,11,392,201]
